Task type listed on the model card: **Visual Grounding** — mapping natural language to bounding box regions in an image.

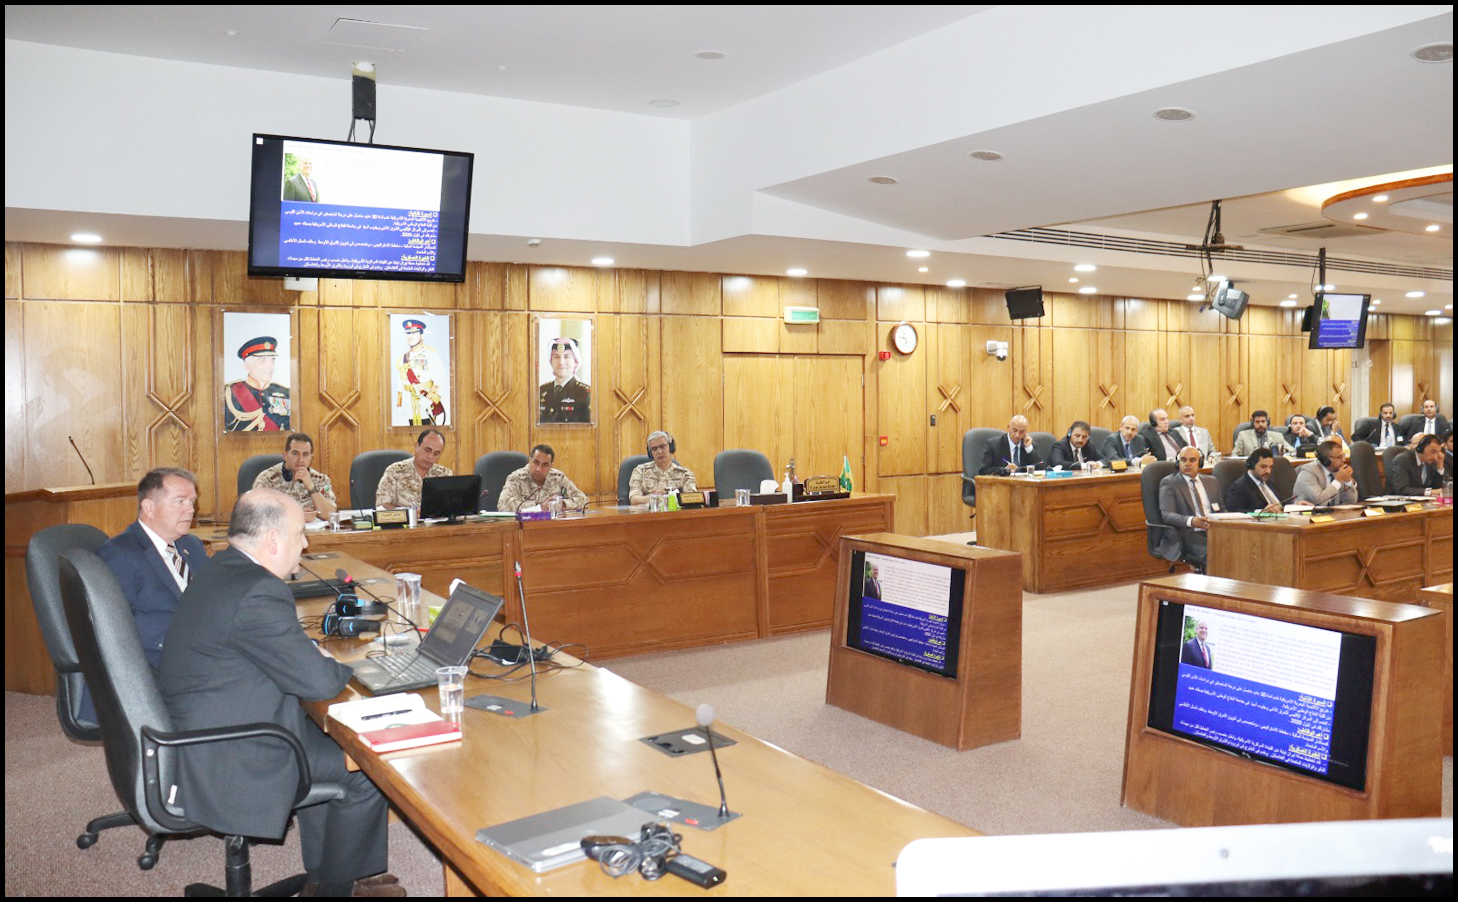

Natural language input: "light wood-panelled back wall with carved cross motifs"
[6,243,1452,535]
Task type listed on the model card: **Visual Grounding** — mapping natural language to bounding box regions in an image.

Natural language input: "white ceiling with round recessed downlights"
[6,6,1454,313]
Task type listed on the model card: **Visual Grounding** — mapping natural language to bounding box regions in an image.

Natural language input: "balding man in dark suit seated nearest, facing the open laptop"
[157,488,404,896]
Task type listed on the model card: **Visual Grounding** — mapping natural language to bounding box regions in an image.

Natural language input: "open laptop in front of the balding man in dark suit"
[350,583,502,695]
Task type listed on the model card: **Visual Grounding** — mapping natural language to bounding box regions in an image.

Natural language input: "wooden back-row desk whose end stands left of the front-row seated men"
[977,469,1169,593]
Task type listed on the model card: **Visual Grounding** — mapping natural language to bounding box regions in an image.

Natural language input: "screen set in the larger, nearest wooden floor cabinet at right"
[1149,600,1376,790]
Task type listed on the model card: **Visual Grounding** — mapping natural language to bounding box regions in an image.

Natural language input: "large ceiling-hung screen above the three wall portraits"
[248,134,475,281]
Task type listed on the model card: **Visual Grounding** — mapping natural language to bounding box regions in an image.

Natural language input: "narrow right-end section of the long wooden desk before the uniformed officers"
[758,495,895,635]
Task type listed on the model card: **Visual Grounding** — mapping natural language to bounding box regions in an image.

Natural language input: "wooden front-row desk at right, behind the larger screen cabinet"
[1207,504,1454,603]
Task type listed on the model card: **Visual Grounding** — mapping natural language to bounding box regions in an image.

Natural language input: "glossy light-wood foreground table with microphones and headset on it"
[300,553,980,896]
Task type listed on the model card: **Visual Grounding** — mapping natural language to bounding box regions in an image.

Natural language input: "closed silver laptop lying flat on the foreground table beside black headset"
[475,796,653,873]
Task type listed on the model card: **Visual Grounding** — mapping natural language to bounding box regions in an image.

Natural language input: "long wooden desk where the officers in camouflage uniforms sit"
[197,494,895,660]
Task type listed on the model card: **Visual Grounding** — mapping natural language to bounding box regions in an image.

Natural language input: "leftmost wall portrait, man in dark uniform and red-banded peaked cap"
[219,310,295,433]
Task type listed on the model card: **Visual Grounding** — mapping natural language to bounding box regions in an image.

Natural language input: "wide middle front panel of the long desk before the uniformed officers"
[507,507,764,660]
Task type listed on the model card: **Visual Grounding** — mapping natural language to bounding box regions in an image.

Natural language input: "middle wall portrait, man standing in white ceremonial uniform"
[388,313,455,427]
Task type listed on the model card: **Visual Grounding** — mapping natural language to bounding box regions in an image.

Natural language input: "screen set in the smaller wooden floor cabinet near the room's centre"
[846,551,967,678]
